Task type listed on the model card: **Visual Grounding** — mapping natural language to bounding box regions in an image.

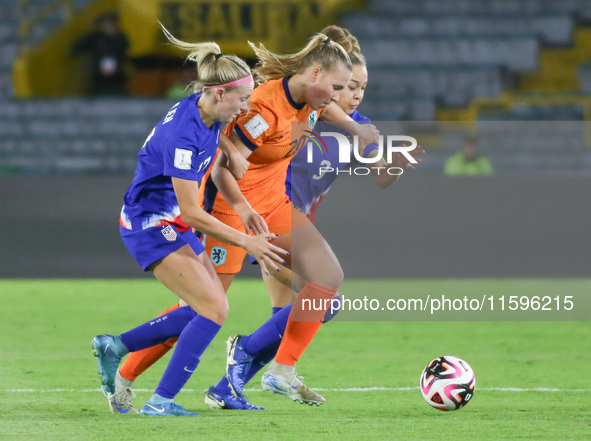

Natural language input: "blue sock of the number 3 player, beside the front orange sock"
[215,305,292,394]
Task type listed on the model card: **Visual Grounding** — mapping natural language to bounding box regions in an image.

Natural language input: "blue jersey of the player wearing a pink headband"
[119,93,222,232]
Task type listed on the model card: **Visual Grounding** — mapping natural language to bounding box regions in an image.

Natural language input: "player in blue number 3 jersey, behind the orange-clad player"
[220,26,424,406]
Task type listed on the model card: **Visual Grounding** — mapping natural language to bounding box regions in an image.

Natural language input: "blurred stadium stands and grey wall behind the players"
[0,0,591,277]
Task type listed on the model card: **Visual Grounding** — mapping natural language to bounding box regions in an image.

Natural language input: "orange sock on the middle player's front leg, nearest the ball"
[275,283,337,366]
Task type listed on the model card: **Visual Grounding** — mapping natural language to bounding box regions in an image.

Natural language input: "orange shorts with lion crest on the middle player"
[201,198,310,274]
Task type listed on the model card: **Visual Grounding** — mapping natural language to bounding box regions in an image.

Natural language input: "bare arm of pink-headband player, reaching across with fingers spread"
[172,177,287,271]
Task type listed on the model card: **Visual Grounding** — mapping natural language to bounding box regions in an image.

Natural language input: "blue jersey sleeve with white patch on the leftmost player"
[163,136,211,181]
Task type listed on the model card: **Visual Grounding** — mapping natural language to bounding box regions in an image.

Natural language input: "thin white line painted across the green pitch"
[3,386,591,393]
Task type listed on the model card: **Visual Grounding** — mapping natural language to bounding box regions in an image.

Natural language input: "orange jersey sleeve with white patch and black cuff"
[234,100,277,152]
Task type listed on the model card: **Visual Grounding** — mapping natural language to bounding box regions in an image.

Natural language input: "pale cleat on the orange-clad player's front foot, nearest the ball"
[261,362,325,406]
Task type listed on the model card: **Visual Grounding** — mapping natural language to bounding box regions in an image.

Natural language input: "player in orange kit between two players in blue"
[110,27,388,409]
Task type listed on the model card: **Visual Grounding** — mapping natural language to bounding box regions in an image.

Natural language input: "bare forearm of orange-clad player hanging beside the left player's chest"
[211,132,269,234]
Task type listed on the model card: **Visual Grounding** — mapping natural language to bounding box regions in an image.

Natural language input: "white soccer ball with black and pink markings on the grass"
[420,355,476,412]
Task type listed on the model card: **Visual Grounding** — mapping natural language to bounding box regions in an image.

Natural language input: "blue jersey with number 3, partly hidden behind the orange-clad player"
[285,110,371,221]
